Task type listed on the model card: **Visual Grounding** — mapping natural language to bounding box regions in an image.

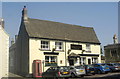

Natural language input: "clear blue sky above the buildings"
[2,2,118,46]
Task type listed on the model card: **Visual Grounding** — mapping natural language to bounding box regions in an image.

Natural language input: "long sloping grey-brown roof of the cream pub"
[25,18,100,44]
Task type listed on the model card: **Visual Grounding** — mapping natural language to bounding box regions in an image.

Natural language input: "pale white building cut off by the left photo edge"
[0,18,9,79]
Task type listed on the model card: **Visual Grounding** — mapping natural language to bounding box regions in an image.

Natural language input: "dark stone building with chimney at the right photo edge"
[104,34,120,63]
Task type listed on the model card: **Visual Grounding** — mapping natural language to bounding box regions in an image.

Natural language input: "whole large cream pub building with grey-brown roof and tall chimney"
[10,7,101,76]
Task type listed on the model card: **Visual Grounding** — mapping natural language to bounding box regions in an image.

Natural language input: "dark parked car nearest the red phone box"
[42,66,71,79]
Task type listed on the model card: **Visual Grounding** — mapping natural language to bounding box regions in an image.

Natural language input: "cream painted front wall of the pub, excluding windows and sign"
[29,38,101,73]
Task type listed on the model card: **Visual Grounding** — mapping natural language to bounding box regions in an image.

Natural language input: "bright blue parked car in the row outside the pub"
[92,63,110,74]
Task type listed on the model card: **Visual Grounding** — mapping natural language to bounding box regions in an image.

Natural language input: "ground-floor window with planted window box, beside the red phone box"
[45,56,57,66]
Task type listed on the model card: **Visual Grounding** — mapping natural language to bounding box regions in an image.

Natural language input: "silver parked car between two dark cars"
[69,65,86,78]
